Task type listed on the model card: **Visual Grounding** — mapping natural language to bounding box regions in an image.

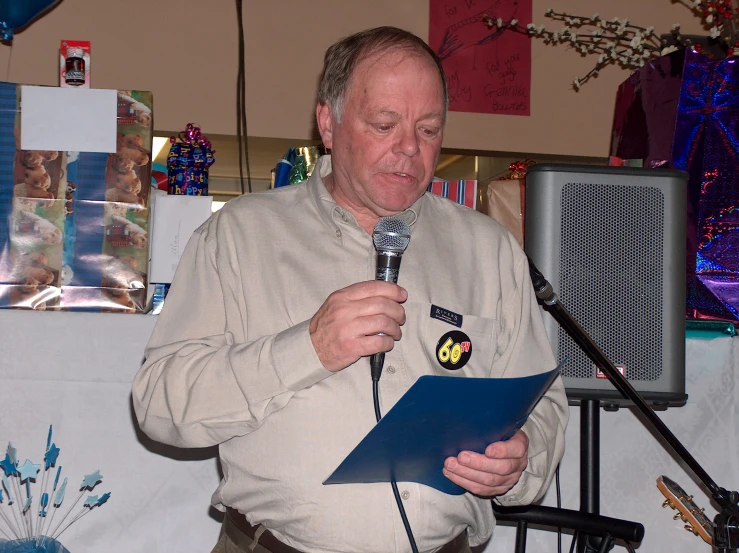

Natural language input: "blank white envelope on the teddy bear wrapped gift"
[21,86,118,153]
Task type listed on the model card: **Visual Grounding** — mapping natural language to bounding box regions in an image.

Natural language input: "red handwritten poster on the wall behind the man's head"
[429,0,532,115]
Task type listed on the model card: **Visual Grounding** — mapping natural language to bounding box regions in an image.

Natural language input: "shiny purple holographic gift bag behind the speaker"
[611,50,739,322]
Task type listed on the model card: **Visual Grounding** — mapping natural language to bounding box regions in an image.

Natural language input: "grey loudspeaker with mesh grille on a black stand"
[525,165,688,408]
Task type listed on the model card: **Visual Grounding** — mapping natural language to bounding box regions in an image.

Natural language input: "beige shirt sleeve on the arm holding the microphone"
[132,217,333,447]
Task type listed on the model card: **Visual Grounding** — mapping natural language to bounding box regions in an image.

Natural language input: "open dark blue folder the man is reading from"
[324,367,559,495]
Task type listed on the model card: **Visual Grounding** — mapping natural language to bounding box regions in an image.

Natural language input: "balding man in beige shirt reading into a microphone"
[133,27,567,553]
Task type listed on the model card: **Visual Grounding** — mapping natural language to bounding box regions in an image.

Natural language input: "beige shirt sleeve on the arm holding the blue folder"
[494,250,569,506]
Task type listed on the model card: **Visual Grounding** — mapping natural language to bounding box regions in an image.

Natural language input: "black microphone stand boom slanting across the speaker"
[529,259,739,553]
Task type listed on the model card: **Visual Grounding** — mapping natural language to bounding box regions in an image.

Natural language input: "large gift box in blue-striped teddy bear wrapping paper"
[0,83,152,312]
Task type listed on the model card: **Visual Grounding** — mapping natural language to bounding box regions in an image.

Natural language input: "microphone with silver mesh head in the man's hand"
[370,217,411,382]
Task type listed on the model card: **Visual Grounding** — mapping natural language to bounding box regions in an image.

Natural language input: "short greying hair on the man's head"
[318,27,449,121]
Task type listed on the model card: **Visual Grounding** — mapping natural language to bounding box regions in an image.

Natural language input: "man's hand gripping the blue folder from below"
[443,430,529,497]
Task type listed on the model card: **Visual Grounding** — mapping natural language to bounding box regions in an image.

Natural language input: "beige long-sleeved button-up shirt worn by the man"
[133,156,568,553]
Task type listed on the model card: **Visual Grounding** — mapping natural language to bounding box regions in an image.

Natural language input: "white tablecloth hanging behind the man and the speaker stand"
[0,311,739,553]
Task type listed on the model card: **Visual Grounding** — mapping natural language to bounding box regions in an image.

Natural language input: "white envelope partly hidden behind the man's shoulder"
[149,196,213,284]
